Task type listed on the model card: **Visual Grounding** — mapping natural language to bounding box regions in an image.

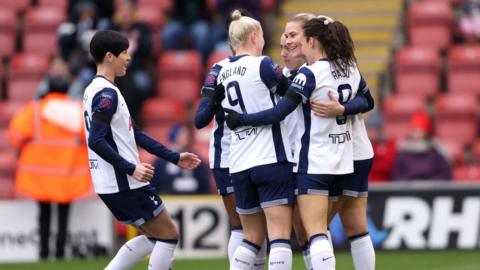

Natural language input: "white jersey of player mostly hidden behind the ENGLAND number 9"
[204,58,232,169]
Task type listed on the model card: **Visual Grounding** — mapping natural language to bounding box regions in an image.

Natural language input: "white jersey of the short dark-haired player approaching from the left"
[83,76,148,194]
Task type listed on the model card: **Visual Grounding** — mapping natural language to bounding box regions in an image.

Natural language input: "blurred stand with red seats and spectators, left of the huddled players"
[0,0,276,197]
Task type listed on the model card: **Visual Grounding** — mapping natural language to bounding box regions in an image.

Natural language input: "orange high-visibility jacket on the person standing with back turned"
[7,93,91,203]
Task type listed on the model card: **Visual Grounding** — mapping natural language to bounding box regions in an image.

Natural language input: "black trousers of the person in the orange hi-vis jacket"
[38,202,70,260]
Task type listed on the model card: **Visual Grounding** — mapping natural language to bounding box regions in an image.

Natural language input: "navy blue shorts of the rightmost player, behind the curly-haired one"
[330,158,373,200]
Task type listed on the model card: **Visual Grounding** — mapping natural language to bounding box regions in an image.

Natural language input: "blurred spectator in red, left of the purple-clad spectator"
[365,111,397,182]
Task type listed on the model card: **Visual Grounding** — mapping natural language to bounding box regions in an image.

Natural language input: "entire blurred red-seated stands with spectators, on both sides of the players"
[0,0,480,202]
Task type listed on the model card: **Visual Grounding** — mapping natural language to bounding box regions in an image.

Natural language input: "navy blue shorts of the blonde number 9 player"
[232,162,295,215]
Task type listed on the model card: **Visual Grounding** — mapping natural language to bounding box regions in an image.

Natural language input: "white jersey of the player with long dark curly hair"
[289,60,360,175]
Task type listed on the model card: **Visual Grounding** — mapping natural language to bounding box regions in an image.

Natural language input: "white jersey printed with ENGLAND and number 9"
[217,55,292,173]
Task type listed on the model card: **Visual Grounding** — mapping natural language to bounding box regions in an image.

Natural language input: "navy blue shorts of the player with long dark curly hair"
[295,173,345,196]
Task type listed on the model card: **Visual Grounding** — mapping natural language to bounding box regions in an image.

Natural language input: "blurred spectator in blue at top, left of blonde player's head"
[161,0,213,62]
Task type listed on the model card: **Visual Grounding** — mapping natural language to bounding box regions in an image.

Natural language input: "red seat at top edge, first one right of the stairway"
[408,0,453,49]
